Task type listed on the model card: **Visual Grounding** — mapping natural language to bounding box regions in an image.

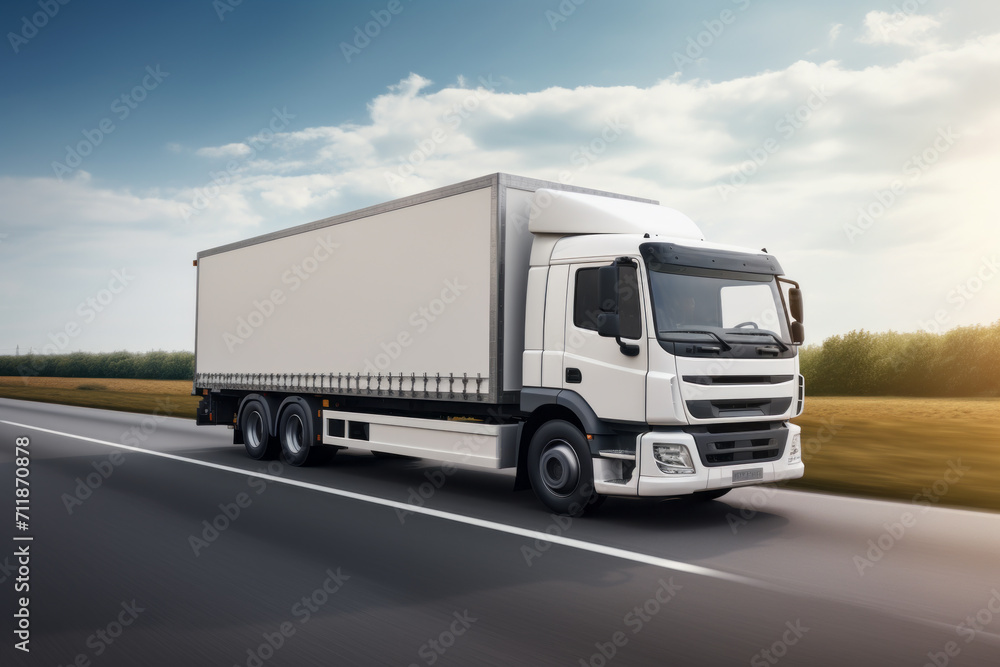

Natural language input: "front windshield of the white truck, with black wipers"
[647,262,789,345]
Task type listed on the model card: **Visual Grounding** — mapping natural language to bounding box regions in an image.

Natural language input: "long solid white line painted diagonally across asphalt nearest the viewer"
[0,419,768,592]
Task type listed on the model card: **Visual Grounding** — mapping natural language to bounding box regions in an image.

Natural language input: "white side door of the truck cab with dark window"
[562,262,649,422]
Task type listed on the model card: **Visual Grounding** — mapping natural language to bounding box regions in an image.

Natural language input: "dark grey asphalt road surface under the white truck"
[0,400,1000,667]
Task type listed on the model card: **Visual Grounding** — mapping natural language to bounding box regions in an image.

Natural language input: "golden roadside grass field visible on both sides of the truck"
[0,377,1000,510]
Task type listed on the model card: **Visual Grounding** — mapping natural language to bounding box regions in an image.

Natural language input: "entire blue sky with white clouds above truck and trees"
[0,0,1000,353]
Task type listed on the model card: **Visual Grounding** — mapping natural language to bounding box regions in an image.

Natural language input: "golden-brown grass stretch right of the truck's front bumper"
[789,397,1000,510]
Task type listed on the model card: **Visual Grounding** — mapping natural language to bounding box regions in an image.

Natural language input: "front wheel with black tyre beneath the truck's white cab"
[528,420,600,516]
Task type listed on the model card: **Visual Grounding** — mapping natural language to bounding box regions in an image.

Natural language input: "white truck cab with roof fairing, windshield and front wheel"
[521,189,804,513]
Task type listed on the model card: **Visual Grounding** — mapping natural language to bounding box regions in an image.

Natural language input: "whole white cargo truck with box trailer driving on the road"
[194,174,804,515]
